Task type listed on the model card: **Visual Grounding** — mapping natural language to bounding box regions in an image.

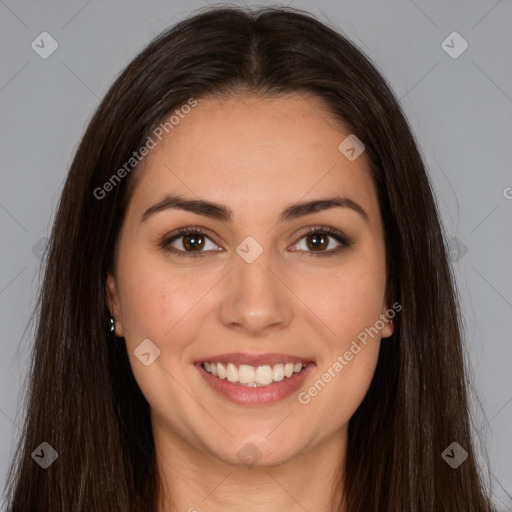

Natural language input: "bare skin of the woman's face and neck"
[107,95,393,512]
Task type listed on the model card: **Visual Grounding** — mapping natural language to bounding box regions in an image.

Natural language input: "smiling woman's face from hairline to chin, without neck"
[107,95,392,465]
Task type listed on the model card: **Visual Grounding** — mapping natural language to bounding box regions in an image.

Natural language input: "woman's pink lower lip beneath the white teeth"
[196,363,315,405]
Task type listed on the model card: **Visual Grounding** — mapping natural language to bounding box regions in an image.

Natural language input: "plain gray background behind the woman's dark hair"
[0,0,512,510]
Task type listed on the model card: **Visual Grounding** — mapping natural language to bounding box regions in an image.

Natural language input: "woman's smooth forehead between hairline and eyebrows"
[126,94,376,221]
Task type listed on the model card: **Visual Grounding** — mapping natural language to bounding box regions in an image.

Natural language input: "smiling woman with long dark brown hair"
[1,8,491,512]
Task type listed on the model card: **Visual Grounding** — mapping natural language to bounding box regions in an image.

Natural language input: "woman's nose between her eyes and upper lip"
[219,246,297,336]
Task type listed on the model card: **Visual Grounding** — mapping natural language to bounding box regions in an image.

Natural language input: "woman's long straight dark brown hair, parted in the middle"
[1,7,491,512]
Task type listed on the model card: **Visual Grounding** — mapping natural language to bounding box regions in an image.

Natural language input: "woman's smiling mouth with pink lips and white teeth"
[195,354,316,405]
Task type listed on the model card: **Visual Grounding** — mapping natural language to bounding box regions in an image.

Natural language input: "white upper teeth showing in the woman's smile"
[202,363,306,387]
